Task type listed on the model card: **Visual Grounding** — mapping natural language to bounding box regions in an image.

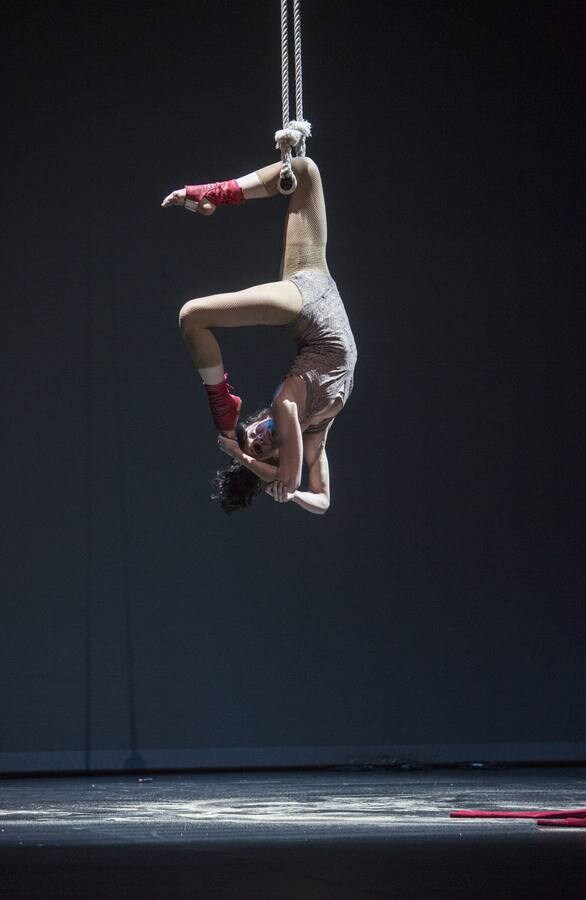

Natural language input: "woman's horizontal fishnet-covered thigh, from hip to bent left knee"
[181,281,303,328]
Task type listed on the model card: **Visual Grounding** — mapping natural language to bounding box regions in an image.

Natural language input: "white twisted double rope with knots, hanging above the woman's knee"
[275,0,311,194]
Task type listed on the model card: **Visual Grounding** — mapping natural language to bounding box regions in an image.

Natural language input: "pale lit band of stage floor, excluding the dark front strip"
[0,772,586,843]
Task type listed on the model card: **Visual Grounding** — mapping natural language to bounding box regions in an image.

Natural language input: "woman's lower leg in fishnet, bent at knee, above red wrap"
[179,281,303,370]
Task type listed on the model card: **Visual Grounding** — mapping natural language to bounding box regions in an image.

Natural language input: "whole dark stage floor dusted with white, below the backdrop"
[0,768,586,900]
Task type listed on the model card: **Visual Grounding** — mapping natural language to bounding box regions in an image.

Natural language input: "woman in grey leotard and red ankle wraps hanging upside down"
[162,157,356,513]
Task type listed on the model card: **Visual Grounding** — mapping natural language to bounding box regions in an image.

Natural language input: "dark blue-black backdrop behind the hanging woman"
[0,0,586,770]
